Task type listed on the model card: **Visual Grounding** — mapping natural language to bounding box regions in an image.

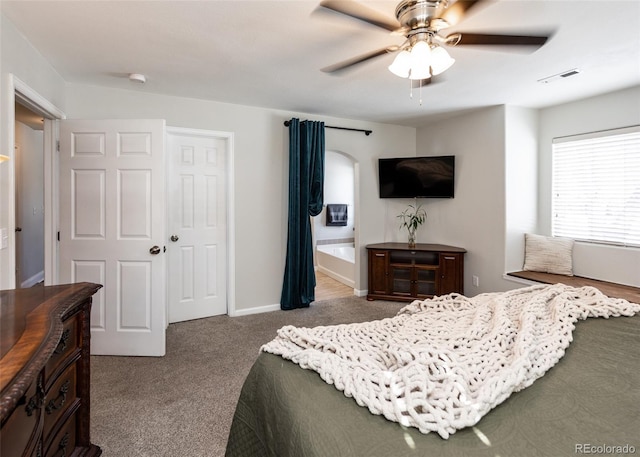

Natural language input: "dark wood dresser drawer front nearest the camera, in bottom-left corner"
[0,382,44,456]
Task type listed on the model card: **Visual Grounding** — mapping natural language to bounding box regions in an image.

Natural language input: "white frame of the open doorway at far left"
[0,73,66,289]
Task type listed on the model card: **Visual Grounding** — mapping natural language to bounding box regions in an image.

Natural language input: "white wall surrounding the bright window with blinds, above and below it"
[538,86,640,286]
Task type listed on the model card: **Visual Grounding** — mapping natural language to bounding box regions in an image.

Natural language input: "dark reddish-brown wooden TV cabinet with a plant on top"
[367,243,467,301]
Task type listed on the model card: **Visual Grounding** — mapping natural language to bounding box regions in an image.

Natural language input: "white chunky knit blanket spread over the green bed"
[262,284,640,439]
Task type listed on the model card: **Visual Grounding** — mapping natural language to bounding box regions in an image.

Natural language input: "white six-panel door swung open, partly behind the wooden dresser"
[59,120,166,356]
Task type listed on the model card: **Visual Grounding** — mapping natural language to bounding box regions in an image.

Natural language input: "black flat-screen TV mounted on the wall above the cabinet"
[378,156,455,198]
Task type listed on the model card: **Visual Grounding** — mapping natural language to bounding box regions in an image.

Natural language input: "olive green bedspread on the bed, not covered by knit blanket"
[226,284,640,457]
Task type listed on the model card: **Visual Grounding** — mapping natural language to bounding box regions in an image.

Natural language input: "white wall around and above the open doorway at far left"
[0,15,65,289]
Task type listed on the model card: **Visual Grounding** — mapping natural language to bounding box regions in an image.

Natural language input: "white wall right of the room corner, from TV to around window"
[416,87,640,295]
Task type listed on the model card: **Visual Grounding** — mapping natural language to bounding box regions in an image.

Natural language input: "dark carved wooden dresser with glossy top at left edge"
[0,282,102,457]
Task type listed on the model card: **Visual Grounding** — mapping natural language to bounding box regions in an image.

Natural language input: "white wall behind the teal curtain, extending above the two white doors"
[66,84,416,313]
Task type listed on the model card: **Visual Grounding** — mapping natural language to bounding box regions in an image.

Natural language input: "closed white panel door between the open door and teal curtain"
[167,129,229,323]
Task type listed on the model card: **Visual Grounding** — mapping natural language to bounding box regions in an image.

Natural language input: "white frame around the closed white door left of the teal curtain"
[165,126,236,318]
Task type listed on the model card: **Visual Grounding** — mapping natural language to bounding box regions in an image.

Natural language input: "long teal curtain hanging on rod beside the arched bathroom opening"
[280,118,324,310]
